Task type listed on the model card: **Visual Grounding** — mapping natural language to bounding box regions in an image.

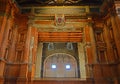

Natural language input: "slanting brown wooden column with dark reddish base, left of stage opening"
[17,24,32,84]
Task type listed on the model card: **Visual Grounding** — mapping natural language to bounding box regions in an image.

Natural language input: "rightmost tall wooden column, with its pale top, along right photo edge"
[111,0,120,81]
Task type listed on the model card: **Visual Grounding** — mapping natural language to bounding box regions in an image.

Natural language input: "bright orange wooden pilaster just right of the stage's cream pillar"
[84,24,97,64]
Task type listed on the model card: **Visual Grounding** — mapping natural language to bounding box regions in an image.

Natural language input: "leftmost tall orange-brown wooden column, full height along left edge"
[0,1,10,84]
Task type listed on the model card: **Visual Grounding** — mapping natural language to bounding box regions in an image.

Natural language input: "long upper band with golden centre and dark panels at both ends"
[22,6,100,15]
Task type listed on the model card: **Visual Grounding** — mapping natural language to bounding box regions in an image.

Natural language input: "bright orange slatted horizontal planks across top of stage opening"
[38,32,83,42]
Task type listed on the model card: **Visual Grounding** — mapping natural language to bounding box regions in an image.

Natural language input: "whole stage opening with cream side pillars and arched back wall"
[35,42,86,79]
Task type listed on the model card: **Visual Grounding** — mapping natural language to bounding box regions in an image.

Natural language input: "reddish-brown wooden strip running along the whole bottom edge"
[3,78,115,84]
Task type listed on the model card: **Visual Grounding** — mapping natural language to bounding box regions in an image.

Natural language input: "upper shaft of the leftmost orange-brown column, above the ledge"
[0,2,11,58]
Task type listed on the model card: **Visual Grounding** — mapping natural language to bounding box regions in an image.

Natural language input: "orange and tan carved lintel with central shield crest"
[30,17,87,32]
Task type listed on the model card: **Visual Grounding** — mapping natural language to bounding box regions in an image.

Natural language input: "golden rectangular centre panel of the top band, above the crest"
[34,6,87,14]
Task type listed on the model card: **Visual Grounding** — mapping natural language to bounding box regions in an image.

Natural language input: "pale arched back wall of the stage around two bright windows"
[42,53,79,77]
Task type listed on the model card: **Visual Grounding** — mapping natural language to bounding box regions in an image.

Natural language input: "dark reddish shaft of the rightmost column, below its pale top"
[111,11,120,84]
